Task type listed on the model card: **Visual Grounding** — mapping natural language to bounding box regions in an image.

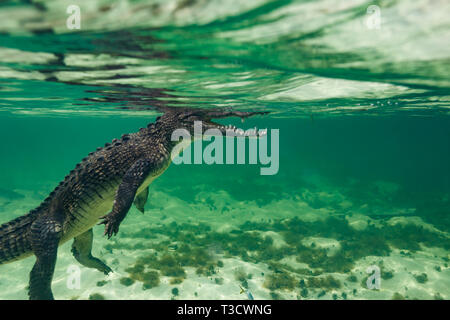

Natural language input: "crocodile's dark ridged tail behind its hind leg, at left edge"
[0,210,37,264]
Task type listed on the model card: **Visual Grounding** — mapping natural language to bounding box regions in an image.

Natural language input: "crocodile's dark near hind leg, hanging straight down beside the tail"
[28,217,62,300]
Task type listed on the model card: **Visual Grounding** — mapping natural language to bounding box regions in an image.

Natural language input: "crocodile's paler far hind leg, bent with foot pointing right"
[72,229,112,274]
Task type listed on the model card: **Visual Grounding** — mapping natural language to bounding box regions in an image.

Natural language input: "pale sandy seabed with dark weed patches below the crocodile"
[0,182,450,300]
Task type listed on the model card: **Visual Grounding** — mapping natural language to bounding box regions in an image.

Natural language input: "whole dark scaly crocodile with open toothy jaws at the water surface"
[0,108,266,300]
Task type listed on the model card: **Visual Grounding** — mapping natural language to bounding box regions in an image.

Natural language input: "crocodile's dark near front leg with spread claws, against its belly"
[99,159,153,239]
